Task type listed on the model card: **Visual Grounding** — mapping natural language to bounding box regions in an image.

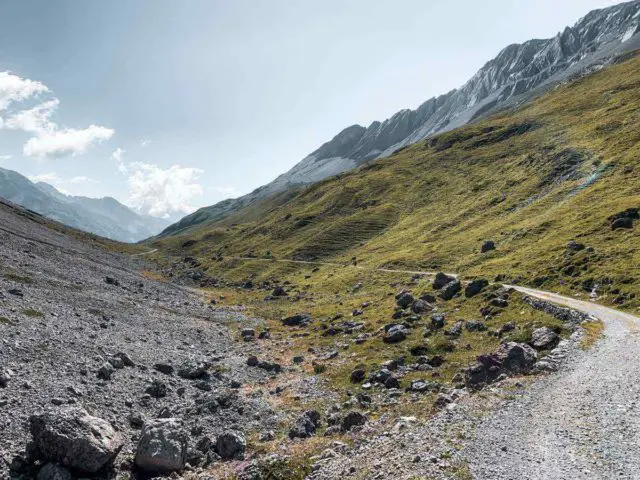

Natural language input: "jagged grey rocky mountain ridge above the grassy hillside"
[163,0,640,235]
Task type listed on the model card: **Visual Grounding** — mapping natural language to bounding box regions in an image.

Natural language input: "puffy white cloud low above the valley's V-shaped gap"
[127,162,203,217]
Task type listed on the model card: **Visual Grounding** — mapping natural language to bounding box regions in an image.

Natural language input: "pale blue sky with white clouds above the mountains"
[0,0,621,218]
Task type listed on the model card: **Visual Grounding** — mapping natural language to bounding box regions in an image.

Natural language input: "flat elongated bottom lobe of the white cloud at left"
[22,125,114,157]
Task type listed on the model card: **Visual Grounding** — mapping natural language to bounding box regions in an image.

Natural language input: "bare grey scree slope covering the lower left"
[0,204,298,479]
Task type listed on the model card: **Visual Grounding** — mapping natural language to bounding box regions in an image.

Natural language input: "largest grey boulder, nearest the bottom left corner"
[29,408,124,473]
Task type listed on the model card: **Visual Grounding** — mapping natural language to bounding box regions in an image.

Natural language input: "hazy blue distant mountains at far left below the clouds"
[0,168,169,242]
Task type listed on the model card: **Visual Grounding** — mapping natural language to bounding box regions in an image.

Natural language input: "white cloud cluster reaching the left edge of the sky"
[0,72,114,157]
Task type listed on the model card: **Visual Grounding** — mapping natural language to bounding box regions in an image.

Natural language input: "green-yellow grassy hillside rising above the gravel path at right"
[155,50,640,308]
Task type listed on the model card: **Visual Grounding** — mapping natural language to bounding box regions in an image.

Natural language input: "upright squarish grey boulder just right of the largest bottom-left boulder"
[135,418,188,473]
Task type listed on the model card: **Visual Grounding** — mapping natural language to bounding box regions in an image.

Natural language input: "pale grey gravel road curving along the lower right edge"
[465,286,640,480]
